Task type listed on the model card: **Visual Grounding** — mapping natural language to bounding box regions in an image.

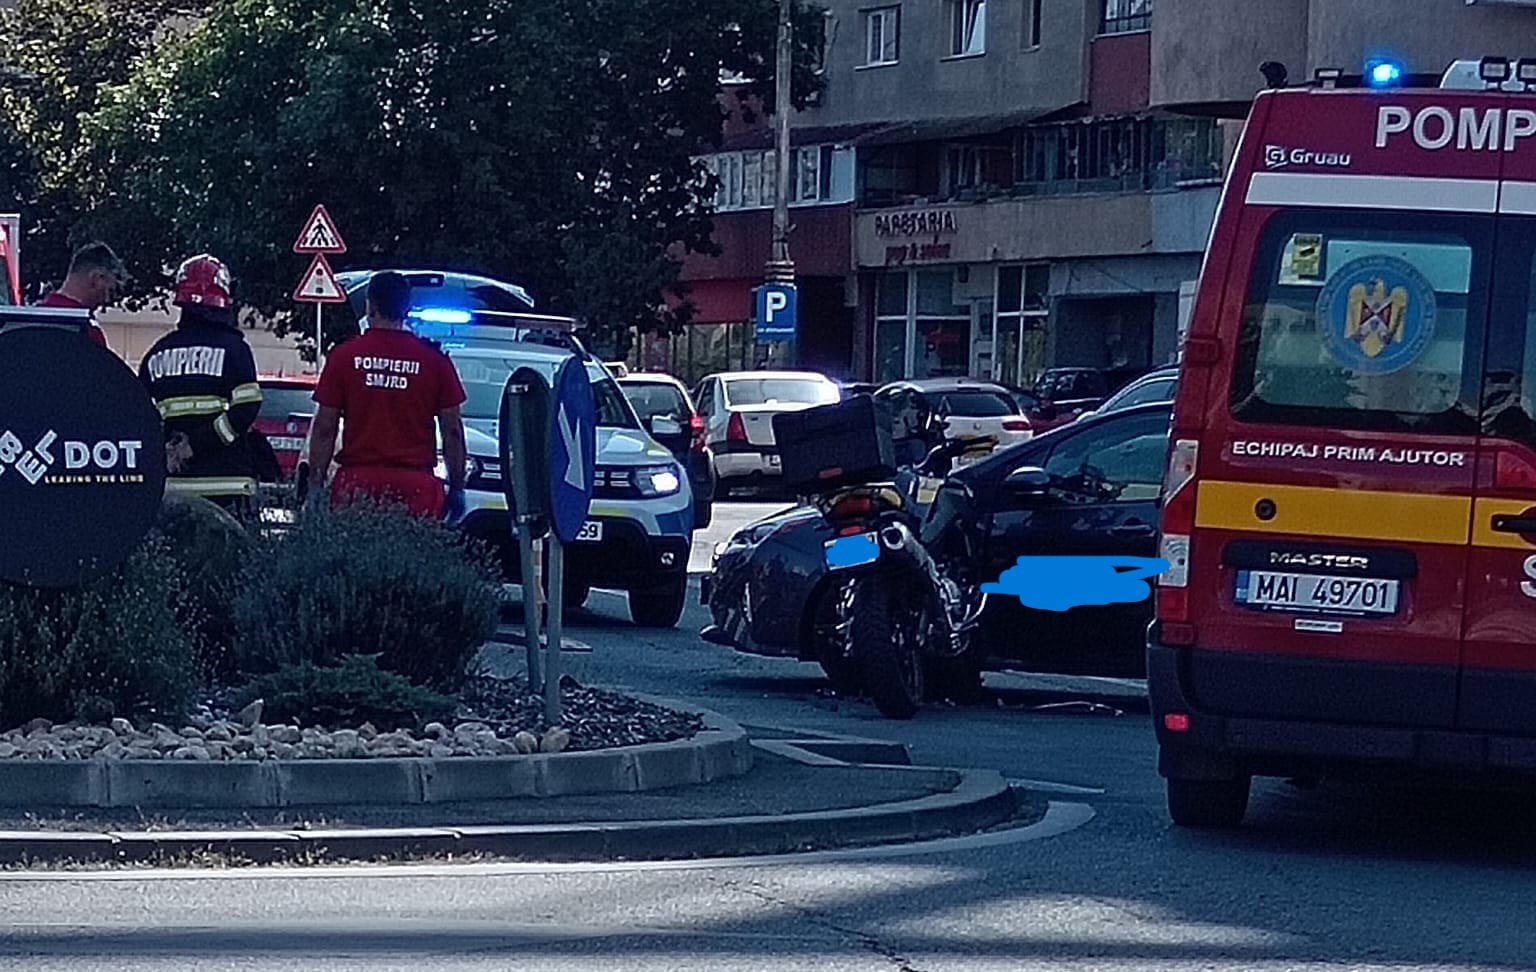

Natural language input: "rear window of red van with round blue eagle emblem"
[1232,213,1487,435]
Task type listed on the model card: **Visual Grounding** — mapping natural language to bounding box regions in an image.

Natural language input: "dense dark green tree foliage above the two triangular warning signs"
[54,0,822,354]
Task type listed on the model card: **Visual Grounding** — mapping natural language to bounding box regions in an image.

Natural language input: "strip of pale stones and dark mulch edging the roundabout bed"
[0,676,703,762]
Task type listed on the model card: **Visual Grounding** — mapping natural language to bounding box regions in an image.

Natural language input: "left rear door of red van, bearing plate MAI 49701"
[1189,208,1496,728]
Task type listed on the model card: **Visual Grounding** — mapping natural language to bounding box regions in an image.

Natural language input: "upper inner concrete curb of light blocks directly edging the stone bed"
[0,699,753,809]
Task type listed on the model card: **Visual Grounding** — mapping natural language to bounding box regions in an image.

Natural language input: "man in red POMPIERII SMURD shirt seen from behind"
[310,272,468,521]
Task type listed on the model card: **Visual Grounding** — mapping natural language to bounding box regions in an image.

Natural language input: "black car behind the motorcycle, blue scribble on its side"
[703,404,1170,677]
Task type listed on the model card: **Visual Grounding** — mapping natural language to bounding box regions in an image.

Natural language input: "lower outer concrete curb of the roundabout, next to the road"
[0,768,1017,863]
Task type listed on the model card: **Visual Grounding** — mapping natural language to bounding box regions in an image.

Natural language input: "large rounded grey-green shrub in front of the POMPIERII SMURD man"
[233,505,499,693]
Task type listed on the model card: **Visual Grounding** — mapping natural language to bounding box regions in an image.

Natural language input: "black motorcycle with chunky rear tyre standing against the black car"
[808,426,989,719]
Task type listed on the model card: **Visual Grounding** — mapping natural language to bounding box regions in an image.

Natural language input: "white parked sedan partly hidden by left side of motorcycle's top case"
[694,372,842,493]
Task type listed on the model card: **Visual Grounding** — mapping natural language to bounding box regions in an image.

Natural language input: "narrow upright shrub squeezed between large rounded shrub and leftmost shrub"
[155,493,253,682]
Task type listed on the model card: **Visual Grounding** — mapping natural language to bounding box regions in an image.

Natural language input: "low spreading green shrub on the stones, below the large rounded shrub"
[235,654,455,729]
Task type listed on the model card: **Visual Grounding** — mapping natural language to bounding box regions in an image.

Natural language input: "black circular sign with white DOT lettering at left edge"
[0,325,166,587]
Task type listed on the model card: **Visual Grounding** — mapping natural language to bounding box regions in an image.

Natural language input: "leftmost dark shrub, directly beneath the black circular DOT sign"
[0,541,195,726]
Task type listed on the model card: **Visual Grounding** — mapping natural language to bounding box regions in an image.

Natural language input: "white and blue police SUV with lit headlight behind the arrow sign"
[441,338,694,628]
